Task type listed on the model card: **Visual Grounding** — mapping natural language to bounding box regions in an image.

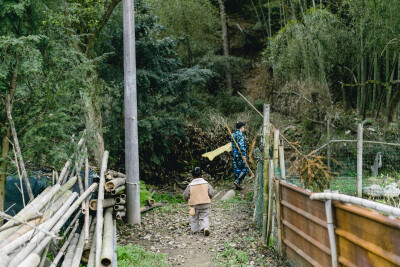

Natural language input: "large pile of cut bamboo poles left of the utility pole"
[0,148,117,267]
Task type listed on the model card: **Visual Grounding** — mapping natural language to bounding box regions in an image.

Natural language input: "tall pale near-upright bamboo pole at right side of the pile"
[95,151,108,266]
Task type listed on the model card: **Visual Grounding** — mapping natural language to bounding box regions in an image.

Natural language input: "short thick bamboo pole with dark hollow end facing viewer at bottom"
[101,208,114,266]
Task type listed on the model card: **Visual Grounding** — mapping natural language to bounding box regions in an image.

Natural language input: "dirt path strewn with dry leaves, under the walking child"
[118,184,287,266]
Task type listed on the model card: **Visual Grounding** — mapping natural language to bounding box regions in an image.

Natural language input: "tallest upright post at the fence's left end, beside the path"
[262,104,271,244]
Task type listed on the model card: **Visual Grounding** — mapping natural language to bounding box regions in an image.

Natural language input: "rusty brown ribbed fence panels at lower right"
[277,181,400,267]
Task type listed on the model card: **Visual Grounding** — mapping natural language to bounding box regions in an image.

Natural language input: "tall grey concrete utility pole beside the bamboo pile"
[123,0,140,225]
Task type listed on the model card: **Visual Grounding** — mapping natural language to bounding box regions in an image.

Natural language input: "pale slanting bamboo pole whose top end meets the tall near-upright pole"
[10,183,98,266]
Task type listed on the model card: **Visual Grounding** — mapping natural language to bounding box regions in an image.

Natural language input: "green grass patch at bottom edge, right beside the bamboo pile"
[117,244,168,267]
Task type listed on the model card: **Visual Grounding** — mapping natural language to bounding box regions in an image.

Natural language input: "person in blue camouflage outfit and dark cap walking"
[231,122,249,190]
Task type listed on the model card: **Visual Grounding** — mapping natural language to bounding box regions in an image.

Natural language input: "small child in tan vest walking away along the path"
[183,167,214,236]
